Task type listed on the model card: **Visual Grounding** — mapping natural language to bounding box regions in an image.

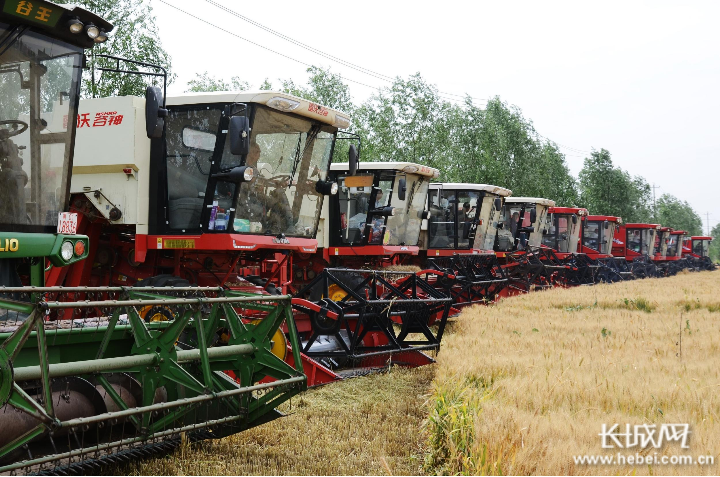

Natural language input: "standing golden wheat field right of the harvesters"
[424,272,720,475]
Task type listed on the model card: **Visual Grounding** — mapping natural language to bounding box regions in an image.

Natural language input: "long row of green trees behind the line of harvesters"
[184,67,697,228]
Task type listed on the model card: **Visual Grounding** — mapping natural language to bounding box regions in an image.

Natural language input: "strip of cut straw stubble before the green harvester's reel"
[112,366,435,476]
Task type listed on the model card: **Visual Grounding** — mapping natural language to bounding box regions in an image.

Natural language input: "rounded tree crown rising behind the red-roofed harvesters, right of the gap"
[580,149,653,223]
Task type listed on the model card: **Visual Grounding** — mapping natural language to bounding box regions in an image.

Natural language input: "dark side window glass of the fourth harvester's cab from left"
[428,190,484,249]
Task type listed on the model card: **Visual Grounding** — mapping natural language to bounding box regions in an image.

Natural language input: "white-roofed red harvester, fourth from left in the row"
[418,183,512,307]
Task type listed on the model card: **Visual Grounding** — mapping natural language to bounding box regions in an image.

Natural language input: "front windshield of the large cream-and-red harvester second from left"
[236,107,337,238]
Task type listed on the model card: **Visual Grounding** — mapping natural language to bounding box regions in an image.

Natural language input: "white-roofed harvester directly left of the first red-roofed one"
[495,197,555,294]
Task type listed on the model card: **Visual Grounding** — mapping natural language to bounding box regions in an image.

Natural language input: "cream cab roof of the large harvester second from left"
[167,91,350,129]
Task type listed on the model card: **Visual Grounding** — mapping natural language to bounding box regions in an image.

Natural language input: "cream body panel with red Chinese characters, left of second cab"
[70,96,150,234]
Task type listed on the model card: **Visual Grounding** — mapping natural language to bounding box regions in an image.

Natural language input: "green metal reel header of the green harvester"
[0,288,307,473]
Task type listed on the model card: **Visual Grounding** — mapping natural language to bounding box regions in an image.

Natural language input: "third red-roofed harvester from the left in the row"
[612,224,662,278]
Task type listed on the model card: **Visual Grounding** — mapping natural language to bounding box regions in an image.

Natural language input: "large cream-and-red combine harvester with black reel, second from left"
[51,91,450,385]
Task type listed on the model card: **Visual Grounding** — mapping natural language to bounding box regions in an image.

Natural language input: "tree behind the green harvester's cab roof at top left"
[56,0,175,97]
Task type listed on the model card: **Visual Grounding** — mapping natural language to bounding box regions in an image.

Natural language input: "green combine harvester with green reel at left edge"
[0,0,307,475]
